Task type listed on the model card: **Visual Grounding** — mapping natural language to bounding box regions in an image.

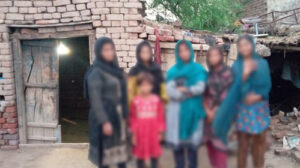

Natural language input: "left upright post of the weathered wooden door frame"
[13,38,27,144]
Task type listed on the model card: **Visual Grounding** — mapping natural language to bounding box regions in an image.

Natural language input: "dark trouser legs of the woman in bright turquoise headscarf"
[174,148,198,168]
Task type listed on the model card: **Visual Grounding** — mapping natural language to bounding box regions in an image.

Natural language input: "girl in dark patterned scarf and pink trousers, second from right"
[203,46,233,168]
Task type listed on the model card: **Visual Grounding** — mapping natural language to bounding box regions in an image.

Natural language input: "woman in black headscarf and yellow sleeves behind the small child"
[128,41,168,103]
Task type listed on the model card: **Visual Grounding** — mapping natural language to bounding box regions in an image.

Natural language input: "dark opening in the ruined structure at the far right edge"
[267,49,300,115]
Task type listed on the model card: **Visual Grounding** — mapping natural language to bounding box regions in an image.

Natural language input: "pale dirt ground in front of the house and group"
[0,145,300,168]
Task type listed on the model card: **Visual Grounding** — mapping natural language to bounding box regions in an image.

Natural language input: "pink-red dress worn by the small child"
[130,95,166,159]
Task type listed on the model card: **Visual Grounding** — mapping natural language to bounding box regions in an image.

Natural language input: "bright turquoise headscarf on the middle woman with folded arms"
[167,40,207,140]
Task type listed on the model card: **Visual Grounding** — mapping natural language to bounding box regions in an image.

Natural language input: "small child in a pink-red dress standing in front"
[130,72,165,168]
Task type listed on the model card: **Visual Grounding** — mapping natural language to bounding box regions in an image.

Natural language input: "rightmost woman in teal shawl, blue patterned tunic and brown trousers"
[213,35,271,168]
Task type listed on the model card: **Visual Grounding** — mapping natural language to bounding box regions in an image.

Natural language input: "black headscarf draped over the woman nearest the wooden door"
[84,37,128,117]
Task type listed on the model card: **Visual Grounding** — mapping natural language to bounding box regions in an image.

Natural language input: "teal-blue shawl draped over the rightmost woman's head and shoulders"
[212,35,271,143]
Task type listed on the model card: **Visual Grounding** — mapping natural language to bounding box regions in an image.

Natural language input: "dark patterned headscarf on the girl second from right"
[204,46,233,108]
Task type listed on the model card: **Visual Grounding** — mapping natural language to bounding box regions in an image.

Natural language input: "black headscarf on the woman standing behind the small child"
[129,40,164,95]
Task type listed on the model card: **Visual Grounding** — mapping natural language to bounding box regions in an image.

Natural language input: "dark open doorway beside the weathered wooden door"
[59,37,90,143]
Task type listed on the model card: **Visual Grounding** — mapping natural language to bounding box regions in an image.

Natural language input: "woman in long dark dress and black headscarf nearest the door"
[84,37,129,168]
